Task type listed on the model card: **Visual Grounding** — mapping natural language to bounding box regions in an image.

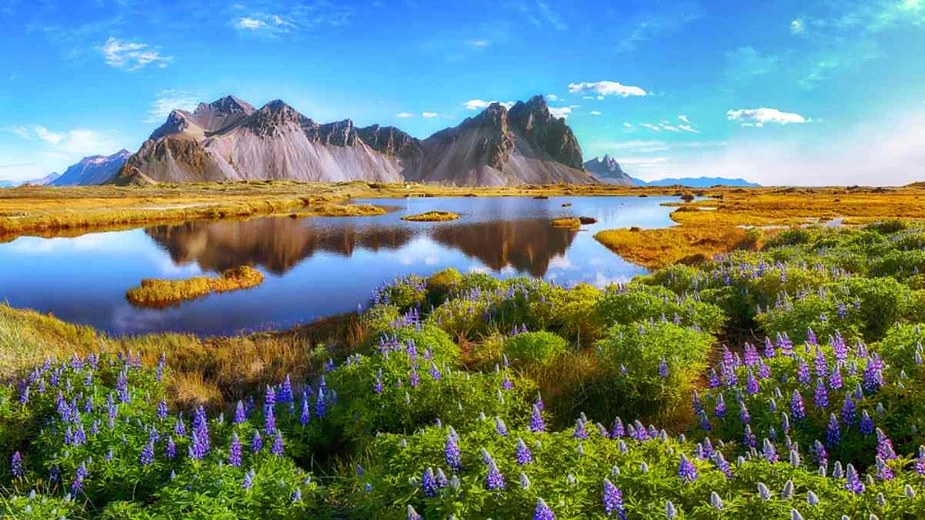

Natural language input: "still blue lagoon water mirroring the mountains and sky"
[0,197,676,334]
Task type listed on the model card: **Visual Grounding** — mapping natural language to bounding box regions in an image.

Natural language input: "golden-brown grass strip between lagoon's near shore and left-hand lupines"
[0,304,366,406]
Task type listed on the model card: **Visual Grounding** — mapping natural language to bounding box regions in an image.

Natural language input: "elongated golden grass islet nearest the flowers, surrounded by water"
[125,265,263,307]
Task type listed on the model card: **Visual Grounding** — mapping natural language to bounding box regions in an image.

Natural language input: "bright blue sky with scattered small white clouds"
[0,0,925,184]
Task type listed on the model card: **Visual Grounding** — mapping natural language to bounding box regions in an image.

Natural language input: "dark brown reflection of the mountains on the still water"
[145,218,577,277]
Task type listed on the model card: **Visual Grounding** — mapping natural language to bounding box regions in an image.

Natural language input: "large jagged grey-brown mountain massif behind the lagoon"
[112,96,594,186]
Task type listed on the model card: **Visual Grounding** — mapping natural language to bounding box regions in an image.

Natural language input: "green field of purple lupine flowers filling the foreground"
[0,221,925,520]
